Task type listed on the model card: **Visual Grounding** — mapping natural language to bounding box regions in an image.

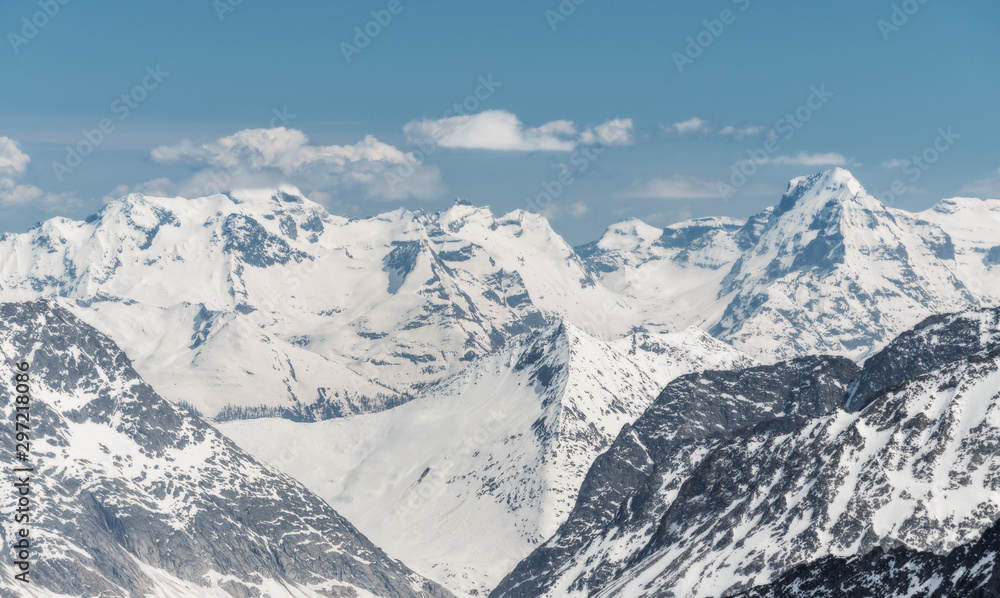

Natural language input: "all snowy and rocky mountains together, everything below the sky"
[0,169,1000,597]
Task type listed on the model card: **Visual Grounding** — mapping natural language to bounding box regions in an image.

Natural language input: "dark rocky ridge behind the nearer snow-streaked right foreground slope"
[491,357,857,597]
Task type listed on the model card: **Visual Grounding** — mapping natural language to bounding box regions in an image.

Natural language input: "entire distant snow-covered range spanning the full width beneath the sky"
[0,169,1000,421]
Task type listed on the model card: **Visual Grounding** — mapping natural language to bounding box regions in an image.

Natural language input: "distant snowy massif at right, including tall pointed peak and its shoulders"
[577,168,1000,361]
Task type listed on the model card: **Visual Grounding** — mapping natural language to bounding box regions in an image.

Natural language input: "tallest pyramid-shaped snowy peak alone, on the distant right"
[711,168,979,358]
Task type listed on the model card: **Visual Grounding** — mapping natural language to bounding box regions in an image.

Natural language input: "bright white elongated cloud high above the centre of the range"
[403,110,577,152]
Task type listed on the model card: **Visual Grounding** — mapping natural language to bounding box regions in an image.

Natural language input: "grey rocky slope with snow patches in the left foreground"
[0,301,450,598]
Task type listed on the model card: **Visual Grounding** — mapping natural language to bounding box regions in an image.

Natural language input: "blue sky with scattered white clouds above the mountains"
[0,0,1000,243]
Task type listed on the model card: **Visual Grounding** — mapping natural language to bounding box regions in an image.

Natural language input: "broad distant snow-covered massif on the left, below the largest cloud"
[0,189,633,419]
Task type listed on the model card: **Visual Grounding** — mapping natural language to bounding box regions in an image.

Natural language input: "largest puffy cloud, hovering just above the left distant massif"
[149,127,443,200]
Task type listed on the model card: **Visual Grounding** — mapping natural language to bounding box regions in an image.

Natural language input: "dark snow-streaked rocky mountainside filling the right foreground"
[493,310,1000,597]
